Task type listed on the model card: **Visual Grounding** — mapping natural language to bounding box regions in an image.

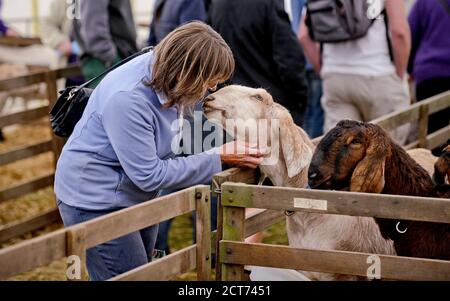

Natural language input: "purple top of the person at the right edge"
[408,0,450,84]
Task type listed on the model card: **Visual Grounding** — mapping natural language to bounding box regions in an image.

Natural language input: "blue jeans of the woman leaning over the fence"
[57,200,158,281]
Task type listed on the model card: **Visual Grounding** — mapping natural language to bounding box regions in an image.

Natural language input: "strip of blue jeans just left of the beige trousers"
[303,71,324,138]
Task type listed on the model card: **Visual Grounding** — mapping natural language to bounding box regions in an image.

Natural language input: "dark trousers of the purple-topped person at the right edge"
[416,77,450,133]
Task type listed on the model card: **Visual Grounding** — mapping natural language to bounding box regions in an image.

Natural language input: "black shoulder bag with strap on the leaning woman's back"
[50,47,153,138]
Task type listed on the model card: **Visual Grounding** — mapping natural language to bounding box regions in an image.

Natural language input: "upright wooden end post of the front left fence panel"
[195,187,211,281]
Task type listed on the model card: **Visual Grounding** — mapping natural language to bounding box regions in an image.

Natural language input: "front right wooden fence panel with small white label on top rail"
[219,183,450,280]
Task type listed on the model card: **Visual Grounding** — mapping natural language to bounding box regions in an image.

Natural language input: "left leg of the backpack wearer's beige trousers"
[321,74,362,133]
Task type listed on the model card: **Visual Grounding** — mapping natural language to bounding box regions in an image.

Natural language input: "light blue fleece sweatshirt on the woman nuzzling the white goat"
[55,53,221,210]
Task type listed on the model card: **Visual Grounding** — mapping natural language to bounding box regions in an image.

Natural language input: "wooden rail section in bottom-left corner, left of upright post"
[0,229,66,279]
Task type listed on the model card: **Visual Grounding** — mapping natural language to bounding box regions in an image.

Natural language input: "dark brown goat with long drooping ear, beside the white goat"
[308,120,450,260]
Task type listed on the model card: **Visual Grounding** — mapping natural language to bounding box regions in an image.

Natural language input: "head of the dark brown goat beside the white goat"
[308,120,391,193]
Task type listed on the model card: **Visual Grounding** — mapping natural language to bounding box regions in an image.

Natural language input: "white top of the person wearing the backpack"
[321,5,395,76]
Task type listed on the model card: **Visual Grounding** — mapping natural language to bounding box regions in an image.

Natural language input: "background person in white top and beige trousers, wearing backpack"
[300,0,411,144]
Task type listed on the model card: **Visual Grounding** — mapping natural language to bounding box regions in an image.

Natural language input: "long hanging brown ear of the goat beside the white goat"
[350,136,388,193]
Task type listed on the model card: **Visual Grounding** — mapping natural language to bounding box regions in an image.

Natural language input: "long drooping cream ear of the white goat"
[280,116,313,178]
